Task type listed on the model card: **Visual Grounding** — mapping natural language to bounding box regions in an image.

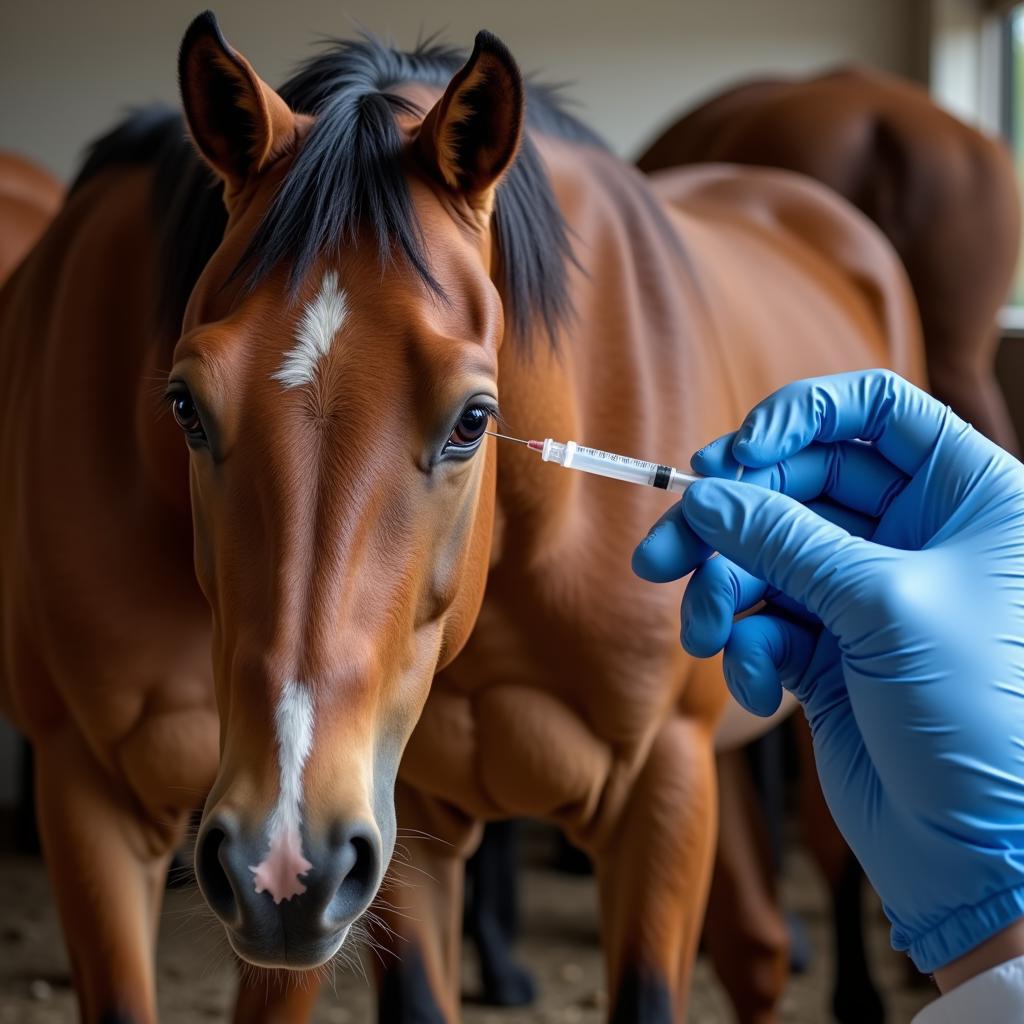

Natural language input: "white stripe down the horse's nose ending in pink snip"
[249,679,313,903]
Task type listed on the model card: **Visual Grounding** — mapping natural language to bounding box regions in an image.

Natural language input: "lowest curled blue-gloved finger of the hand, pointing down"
[722,614,817,717]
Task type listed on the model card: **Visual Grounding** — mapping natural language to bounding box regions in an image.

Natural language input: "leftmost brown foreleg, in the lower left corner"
[36,725,187,1024]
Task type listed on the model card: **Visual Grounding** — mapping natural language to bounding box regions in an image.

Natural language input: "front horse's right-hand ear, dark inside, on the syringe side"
[420,32,524,209]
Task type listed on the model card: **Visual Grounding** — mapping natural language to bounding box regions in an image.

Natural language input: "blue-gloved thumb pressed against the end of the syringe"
[682,479,867,626]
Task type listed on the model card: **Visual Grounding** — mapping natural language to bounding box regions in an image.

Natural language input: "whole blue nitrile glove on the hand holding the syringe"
[634,371,1024,971]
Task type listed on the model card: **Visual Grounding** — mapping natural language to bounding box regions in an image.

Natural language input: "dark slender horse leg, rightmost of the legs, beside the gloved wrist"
[794,715,886,1024]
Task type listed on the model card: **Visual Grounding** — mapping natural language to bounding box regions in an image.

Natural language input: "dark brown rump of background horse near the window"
[637,61,1021,452]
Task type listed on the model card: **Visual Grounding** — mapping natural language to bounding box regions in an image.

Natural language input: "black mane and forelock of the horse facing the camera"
[72,38,604,342]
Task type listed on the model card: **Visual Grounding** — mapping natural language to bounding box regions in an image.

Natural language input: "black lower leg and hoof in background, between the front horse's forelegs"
[466,821,537,1007]
